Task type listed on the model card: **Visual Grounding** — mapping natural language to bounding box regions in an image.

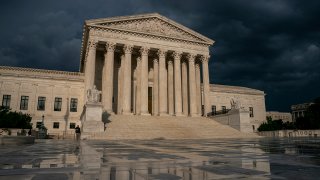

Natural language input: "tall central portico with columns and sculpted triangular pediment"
[80,14,213,116]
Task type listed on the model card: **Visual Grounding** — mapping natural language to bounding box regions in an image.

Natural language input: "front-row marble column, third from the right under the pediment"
[173,52,182,116]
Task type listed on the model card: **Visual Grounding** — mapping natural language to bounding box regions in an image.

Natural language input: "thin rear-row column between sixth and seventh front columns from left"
[181,61,189,116]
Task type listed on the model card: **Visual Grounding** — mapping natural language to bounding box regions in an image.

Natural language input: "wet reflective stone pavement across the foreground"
[0,138,320,180]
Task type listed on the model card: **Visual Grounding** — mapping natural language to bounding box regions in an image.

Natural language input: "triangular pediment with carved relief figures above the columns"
[86,13,214,45]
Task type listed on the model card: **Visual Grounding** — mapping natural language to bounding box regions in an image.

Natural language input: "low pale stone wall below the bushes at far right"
[258,129,320,137]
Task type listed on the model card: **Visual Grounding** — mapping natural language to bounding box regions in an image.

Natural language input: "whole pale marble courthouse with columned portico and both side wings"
[0,13,265,133]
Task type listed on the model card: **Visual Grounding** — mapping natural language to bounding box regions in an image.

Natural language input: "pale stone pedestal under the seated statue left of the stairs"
[82,102,104,133]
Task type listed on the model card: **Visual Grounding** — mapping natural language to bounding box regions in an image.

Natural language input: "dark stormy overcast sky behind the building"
[0,0,320,111]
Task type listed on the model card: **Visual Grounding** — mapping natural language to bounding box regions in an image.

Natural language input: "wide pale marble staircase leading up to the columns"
[83,115,257,140]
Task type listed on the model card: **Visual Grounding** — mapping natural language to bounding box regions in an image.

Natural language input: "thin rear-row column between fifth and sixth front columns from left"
[168,60,174,116]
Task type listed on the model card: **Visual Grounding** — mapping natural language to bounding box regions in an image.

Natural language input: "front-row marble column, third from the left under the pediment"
[122,45,133,114]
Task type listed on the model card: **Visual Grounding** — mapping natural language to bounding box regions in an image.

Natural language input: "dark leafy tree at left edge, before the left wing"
[0,106,32,129]
